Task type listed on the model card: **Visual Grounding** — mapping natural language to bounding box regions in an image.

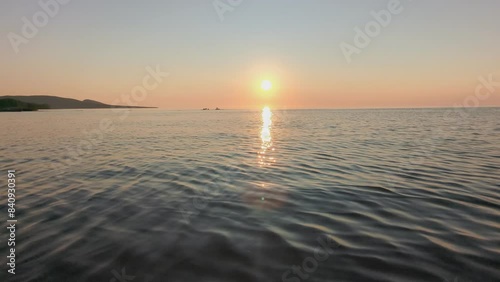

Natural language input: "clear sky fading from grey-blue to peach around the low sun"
[0,0,500,109]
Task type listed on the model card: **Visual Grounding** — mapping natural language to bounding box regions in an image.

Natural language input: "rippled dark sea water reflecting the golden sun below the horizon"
[0,108,500,282]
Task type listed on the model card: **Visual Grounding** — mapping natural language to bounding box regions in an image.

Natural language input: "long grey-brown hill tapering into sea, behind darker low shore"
[0,95,154,109]
